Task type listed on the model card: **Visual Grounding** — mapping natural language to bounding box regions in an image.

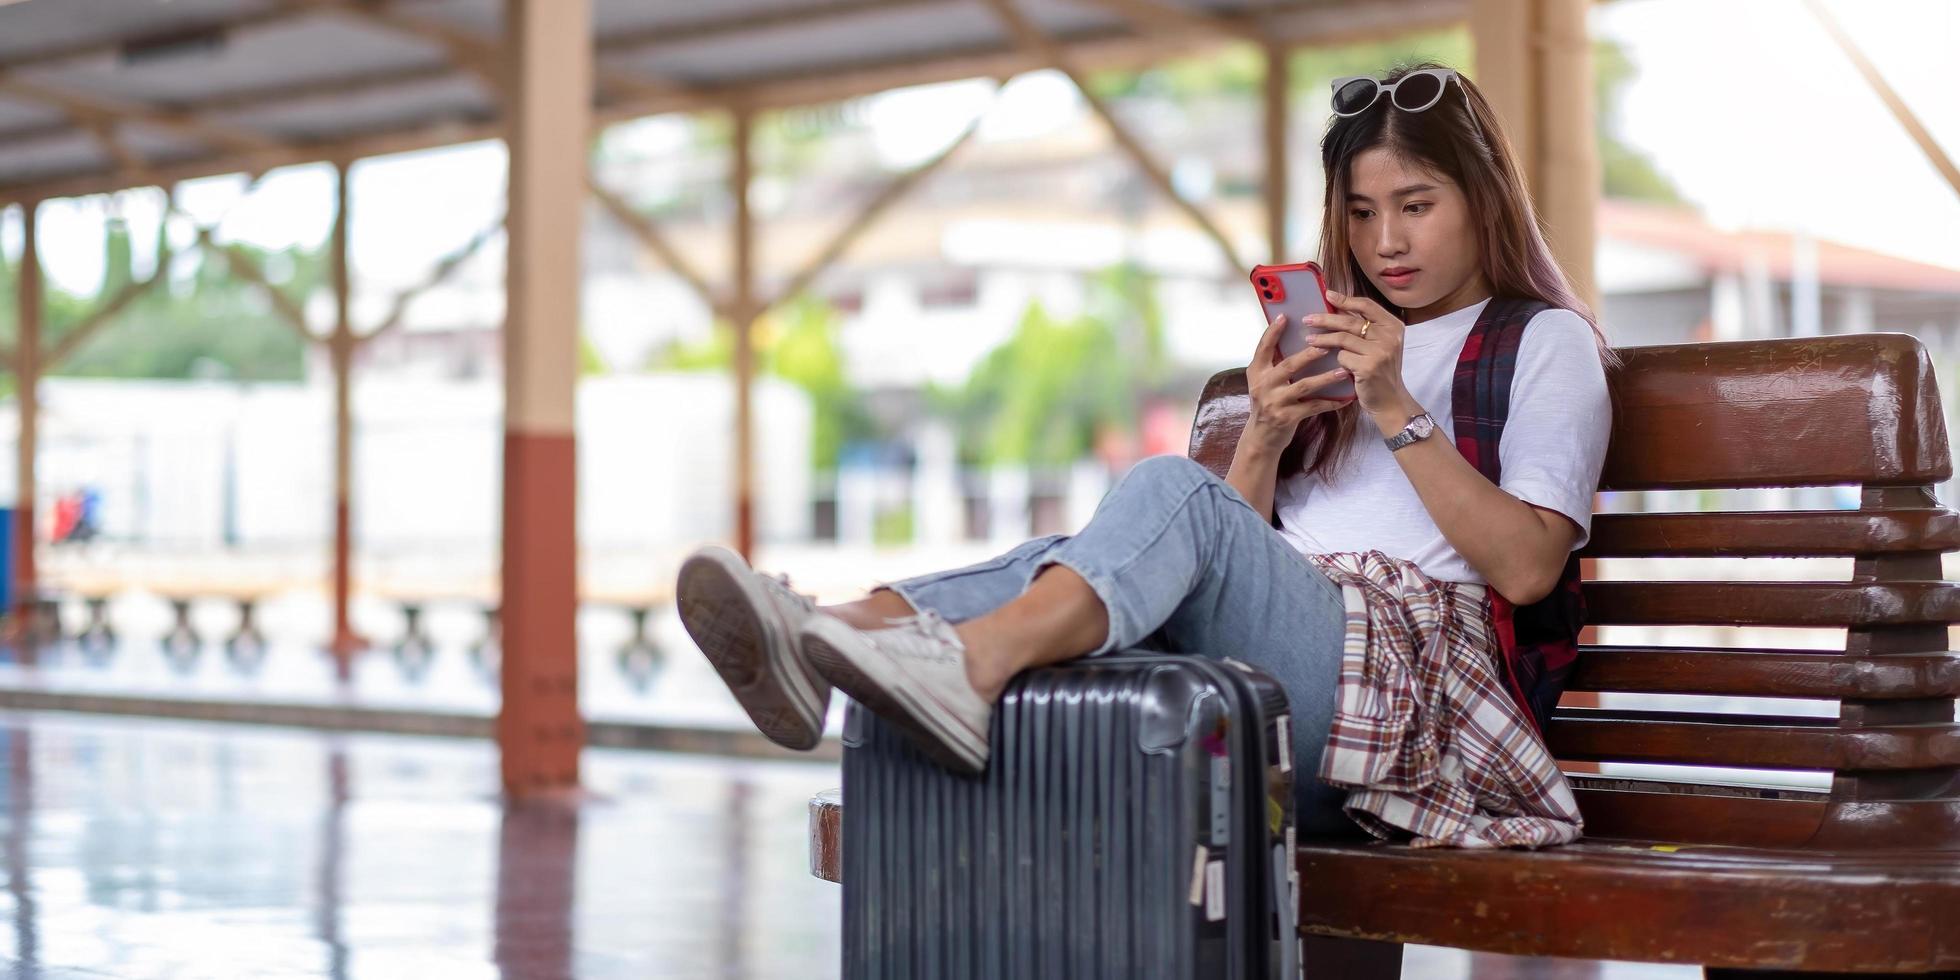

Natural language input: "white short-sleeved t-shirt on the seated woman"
[1274,300,1613,584]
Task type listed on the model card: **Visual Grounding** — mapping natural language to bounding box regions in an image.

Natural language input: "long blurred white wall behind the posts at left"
[0,374,811,553]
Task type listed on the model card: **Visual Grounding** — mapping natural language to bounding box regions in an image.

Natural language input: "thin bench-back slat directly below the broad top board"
[1580,508,1960,559]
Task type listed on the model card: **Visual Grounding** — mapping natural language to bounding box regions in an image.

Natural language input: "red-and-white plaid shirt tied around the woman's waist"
[1307,551,1584,847]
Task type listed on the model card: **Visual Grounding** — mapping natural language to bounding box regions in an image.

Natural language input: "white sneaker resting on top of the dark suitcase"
[802,610,994,772]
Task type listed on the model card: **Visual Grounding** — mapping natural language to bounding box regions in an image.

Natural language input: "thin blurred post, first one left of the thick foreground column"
[327,161,365,680]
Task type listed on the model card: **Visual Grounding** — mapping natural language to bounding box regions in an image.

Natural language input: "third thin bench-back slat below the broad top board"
[1568,647,1960,700]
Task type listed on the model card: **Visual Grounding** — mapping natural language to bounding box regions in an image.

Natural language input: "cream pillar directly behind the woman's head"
[1470,0,1601,310]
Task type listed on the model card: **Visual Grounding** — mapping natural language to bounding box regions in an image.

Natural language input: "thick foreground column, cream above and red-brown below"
[498,0,592,798]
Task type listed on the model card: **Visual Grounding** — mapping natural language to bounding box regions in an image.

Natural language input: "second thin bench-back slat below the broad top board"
[1584,582,1960,627]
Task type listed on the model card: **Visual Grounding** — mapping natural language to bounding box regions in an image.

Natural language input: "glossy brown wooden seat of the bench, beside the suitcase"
[1298,841,1960,972]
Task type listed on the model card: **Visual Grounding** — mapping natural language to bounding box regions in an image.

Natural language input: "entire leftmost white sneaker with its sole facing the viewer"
[674,547,831,749]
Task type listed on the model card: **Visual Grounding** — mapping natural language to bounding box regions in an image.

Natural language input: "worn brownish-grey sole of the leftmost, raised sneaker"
[674,551,823,749]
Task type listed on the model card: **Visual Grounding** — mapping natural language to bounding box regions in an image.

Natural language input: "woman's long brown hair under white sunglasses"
[1278,61,1619,478]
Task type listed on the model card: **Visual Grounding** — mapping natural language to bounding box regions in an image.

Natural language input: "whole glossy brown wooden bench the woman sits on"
[811,333,1960,980]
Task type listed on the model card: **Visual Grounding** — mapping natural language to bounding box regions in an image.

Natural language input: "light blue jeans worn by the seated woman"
[882,457,1362,837]
